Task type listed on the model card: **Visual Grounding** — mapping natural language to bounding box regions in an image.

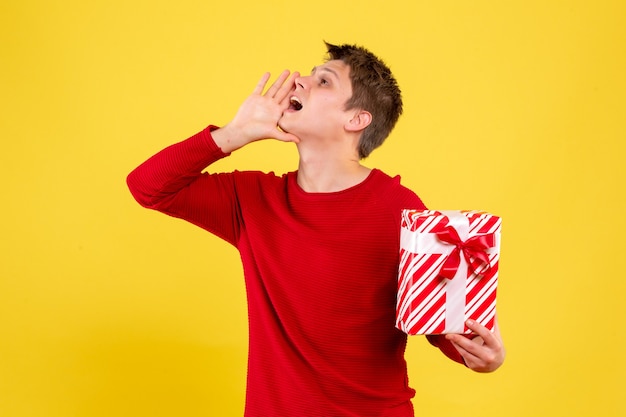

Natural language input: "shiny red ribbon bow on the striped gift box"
[435,226,496,279]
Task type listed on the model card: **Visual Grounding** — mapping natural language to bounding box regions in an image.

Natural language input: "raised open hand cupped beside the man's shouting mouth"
[212,70,300,153]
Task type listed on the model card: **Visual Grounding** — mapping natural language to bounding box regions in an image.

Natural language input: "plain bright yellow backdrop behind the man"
[0,0,626,417]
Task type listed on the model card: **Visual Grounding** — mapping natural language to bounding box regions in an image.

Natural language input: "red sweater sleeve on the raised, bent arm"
[126,126,239,243]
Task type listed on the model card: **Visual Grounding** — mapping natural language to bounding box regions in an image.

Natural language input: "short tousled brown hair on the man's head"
[324,42,402,159]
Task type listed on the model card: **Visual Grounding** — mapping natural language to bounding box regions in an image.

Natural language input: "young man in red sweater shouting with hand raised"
[128,44,504,417]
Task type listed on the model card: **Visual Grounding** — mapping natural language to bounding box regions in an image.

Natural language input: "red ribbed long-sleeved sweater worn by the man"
[128,127,460,417]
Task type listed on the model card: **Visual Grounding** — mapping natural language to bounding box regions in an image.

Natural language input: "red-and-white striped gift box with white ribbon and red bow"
[396,210,501,335]
